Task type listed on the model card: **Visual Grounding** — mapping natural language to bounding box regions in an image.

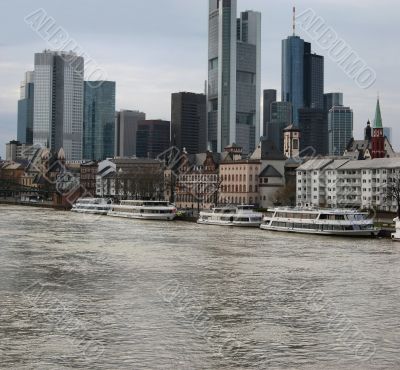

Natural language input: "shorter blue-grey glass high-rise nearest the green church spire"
[328,106,353,155]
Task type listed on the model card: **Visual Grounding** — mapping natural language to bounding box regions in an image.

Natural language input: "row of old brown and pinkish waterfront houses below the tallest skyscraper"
[172,140,286,209]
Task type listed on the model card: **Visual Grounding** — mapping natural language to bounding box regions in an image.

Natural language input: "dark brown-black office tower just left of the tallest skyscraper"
[171,92,207,154]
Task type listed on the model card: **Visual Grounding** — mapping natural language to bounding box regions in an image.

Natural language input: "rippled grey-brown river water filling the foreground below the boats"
[0,206,400,369]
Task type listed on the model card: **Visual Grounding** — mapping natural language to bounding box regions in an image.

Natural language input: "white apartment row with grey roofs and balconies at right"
[296,158,400,212]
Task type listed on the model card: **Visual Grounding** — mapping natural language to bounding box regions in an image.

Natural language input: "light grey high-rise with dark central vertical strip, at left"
[33,50,84,160]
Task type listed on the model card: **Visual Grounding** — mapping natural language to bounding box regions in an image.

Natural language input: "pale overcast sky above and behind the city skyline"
[0,0,400,158]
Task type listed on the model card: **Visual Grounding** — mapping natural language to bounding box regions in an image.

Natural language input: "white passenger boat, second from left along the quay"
[108,200,176,221]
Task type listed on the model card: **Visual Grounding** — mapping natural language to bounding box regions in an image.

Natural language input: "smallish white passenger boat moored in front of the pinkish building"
[197,205,262,227]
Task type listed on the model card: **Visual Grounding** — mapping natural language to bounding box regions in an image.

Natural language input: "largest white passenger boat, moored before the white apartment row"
[260,208,379,236]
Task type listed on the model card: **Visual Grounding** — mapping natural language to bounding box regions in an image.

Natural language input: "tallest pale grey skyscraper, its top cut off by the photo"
[208,0,261,153]
